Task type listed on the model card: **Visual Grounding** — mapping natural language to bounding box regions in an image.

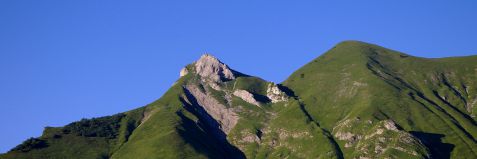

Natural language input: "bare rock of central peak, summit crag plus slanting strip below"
[180,54,248,135]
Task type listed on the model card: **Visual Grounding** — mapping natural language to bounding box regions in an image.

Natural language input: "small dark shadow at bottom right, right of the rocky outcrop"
[409,131,455,159]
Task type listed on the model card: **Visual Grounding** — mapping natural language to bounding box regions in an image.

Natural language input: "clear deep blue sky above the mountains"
[0,0,477,152]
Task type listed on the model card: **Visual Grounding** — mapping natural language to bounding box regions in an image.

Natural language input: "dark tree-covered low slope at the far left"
[0,108,143,159]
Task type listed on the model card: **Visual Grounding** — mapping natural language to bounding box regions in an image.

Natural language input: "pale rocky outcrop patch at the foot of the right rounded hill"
[333,118,429,158]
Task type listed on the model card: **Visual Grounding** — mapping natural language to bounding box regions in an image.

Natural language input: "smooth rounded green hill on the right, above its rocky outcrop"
[283,41,477,158]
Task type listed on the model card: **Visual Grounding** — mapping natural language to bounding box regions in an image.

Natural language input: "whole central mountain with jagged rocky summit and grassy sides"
[108,55,340,158]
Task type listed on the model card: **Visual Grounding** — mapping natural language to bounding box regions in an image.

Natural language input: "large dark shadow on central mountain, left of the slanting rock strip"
[177,89,245,159]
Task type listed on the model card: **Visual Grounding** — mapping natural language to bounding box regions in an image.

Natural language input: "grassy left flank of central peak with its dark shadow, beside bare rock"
[111,76,242,158]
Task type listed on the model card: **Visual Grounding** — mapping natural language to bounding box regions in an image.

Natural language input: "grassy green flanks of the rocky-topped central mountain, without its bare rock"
[112,65,341,158]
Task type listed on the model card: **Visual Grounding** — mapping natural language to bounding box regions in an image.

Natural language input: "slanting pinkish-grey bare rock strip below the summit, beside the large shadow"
[185,85,239,134]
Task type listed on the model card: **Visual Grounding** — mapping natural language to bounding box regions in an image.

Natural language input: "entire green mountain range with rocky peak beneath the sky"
[0,41,477,159]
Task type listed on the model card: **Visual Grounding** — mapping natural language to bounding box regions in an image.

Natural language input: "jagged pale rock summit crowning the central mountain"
[194,54,236,82]
